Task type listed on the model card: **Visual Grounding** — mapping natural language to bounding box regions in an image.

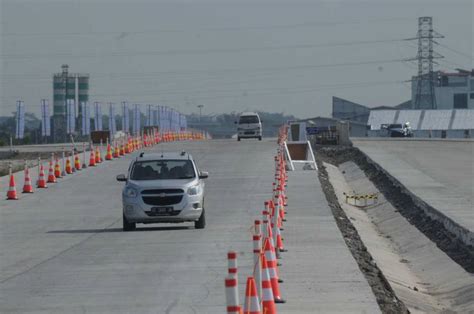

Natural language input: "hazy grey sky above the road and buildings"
[0,0,474,118]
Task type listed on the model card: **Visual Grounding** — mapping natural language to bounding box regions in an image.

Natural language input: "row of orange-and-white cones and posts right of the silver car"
[225,129,288,314]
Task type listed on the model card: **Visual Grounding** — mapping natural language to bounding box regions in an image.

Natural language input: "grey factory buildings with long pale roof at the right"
[332,69,474,138]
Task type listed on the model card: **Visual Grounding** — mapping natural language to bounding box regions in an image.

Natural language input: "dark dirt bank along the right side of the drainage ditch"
[315,147,474,273]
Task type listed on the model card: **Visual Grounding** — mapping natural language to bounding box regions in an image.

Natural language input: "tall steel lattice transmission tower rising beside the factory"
[409,16,444,109]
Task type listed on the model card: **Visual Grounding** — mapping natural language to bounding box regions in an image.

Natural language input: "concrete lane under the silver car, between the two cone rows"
[0,140,277,313]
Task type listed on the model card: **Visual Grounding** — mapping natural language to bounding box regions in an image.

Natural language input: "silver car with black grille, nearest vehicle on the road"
[117,152,208,231]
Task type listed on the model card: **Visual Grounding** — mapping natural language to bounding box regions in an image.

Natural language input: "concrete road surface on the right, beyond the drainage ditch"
[353,139,474,244]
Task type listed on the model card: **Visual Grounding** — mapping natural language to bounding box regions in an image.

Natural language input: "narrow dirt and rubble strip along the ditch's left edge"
[316,153,410,314]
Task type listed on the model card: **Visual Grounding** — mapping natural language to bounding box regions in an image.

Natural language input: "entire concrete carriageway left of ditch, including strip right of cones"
[0,140,378,313]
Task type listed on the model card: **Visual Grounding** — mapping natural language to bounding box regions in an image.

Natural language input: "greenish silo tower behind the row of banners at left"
[52,64,89,142]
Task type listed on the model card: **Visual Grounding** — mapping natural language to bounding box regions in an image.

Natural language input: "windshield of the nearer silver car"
[130,160,196,181]
